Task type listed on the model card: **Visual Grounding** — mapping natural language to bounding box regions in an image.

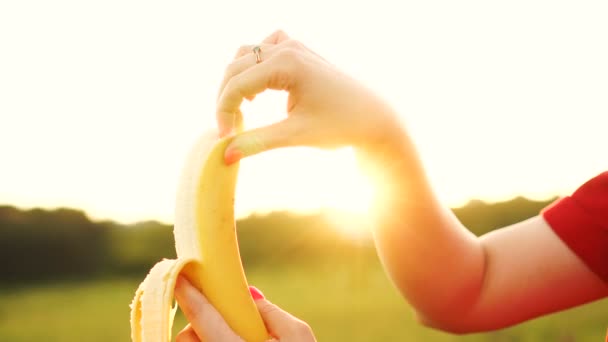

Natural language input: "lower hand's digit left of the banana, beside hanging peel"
[175,276,242,341]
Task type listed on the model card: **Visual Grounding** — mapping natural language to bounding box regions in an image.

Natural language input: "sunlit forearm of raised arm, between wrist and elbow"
[358,123,485,326]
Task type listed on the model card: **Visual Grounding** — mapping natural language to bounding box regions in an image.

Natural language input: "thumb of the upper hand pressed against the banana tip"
[224,115,306,164]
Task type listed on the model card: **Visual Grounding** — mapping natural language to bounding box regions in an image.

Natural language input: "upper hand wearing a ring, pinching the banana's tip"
[217,31,400,163]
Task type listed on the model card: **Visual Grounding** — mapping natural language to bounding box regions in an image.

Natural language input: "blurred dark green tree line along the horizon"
[0,197,552,283]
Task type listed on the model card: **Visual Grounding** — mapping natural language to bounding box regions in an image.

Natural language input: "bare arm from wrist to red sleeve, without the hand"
[359,131,608,333]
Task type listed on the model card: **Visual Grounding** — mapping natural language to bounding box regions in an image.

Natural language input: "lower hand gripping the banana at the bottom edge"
[175,276,315,342]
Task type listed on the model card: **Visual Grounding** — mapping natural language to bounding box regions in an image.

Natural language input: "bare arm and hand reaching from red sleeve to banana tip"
[179,31,608,340]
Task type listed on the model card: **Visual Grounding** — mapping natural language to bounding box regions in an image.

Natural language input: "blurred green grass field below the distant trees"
[0,265,608,342]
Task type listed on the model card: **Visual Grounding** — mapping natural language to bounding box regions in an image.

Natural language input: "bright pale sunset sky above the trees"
[0,0,608,222]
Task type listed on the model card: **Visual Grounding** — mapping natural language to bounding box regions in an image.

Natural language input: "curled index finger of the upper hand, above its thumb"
[216,49,300,137]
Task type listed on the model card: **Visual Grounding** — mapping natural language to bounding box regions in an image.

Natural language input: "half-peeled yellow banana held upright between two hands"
[130,132,269,342]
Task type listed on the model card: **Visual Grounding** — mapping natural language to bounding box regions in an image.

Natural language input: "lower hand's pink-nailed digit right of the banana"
[255,299,314,341]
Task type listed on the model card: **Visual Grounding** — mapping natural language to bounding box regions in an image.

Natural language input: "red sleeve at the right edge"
[542,172,608,283]
